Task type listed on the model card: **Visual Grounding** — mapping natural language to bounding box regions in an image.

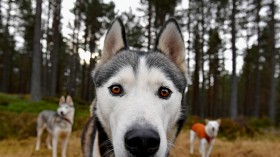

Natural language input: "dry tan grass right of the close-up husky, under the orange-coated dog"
[171,131,280,157]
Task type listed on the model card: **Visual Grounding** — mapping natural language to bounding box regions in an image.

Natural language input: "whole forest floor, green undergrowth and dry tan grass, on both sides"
[0,93,280,157]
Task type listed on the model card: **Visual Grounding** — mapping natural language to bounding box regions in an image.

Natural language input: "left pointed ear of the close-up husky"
[101,18,128,62]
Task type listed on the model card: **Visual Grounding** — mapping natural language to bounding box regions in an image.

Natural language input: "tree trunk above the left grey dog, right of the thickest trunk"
[50,0,61,96]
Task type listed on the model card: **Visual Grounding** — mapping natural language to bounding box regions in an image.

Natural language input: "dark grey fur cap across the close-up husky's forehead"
[93,50,186,93]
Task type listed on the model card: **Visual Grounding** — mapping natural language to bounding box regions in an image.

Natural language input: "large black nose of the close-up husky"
[124,129,160,157]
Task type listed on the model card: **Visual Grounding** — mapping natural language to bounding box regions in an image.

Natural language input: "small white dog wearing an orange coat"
[190,119,221,157]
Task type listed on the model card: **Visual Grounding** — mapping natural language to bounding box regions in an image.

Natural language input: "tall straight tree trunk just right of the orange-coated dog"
[230,0,238,119]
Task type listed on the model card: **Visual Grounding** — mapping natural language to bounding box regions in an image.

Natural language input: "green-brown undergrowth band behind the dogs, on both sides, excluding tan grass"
[0,93,278,141]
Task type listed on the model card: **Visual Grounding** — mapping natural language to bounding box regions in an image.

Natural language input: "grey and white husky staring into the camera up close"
[81,18,187,157]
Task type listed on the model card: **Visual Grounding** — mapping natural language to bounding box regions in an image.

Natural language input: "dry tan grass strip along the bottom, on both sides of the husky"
[0,131,280,157]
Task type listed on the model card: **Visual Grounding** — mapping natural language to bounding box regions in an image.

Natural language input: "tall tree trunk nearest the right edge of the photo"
[268,0,276,122]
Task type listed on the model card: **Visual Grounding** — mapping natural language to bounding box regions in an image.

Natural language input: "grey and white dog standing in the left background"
[36,96,75,157]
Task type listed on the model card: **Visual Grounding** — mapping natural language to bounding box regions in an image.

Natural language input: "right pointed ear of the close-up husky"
[155,18,186,72]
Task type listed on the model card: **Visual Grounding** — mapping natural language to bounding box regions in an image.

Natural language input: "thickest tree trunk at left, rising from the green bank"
[31,0,42,101]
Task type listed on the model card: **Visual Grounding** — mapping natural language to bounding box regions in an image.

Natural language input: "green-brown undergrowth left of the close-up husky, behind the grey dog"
[0,93,89,140]
